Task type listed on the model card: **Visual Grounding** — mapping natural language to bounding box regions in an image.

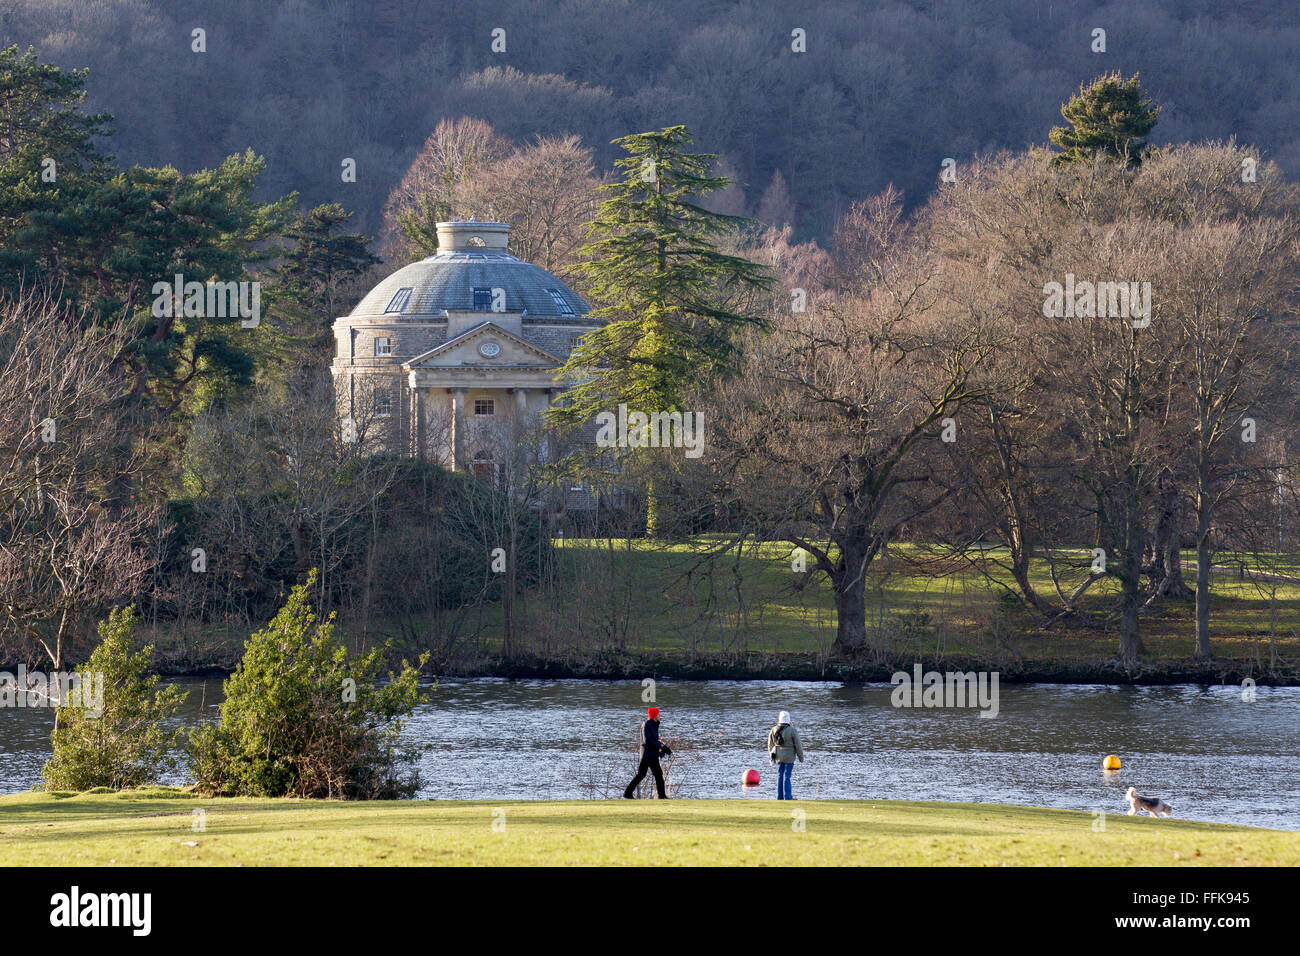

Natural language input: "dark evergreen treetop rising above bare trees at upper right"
[1048,72,1160,166]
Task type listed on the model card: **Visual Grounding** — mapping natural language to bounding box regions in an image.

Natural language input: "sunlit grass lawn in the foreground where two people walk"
[0,788,1300,866]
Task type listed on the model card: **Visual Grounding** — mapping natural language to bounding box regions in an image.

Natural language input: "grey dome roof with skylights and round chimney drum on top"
[351,222,592,319]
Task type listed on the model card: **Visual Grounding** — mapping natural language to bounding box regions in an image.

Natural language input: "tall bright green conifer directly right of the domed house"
[553,126,771,536]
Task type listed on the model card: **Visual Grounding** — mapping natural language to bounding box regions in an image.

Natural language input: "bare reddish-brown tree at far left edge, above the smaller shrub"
[0,293,160,670]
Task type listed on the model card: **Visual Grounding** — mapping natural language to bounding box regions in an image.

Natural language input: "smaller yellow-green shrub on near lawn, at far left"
[40,607,186,791]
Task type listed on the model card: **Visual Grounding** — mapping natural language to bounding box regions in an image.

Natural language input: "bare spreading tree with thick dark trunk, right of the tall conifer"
[710,194,989,654]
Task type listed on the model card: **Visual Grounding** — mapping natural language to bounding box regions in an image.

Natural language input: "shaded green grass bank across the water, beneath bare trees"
[147,535,1300,684]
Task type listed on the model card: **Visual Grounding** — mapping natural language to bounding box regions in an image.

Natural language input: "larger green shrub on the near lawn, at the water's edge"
[191,571,429,800]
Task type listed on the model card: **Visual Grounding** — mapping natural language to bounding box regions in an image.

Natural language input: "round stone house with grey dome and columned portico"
[333,221,599,489]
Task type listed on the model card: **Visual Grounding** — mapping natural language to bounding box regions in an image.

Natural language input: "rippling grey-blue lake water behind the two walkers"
[0,679,1300,830]
